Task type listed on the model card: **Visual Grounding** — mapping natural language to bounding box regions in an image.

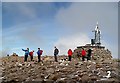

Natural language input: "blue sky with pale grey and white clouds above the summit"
[1,2,118,58]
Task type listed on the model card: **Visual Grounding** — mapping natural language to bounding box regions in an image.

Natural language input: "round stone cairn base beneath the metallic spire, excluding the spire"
[73,44,112,60]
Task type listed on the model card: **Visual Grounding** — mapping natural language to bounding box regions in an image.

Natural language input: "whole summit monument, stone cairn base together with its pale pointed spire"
[73,22,112,61]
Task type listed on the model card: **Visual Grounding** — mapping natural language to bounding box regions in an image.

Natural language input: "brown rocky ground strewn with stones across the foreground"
[0,56,120,83]
